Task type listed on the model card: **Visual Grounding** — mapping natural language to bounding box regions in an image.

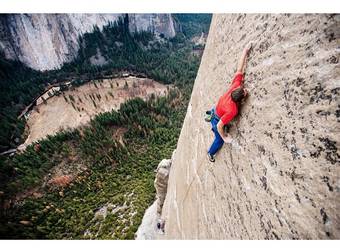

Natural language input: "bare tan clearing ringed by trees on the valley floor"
[19,76,169,149]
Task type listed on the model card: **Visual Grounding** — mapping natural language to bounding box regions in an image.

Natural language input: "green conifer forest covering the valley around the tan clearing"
[0,14,211,239]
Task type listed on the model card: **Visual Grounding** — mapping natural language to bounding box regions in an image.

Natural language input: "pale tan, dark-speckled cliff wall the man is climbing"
[160,15,340,239]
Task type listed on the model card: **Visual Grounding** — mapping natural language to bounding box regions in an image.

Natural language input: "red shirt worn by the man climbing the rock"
[216,73,243,125]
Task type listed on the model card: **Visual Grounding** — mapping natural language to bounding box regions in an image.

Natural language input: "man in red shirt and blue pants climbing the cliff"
[205,42,252,162]
